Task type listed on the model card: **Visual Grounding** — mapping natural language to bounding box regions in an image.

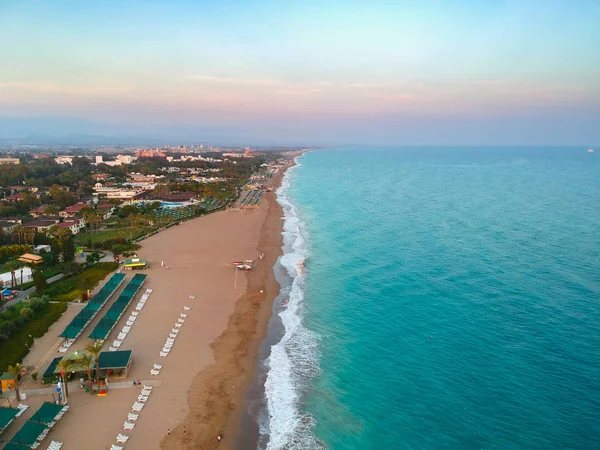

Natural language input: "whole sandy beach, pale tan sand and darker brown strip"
[3,170,282,449]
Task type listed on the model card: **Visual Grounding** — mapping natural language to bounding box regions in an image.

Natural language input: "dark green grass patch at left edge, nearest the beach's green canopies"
[0,299,67,372]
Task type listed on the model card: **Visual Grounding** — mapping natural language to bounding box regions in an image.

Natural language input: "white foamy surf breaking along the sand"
[261,159,324,450]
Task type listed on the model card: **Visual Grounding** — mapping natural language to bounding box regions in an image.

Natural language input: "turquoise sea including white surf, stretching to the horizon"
[241,147,600,450]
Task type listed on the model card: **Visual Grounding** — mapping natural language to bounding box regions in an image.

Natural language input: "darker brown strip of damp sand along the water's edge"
[161,163,293,450]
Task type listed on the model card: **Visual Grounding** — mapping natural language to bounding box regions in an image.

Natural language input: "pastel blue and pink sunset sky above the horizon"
[0,0,600,145]
